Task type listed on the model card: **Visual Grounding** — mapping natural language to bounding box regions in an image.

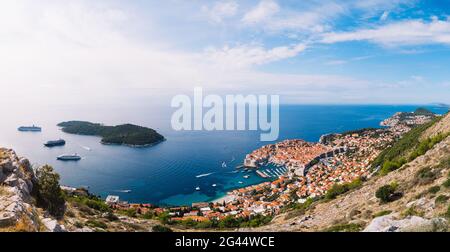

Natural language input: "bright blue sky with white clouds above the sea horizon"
[0,0,450,104]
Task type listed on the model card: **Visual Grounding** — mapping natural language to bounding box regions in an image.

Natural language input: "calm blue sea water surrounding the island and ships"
[0,105,447,205]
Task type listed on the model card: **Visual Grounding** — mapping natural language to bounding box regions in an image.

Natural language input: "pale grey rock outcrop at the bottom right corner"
[364,214,447,232]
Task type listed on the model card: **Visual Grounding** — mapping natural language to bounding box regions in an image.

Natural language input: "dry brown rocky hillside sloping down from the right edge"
[250,115,450,231]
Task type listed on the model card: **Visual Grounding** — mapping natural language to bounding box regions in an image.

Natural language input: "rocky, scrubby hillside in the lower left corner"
[0,148,165,232]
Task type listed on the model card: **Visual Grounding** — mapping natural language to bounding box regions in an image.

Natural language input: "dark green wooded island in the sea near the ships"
[58,121,164,146]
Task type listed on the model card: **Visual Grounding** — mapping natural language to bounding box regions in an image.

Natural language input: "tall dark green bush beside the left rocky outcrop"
[35,165,66,218]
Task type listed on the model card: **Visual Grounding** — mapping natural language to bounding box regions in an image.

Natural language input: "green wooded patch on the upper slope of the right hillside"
[372,118,450,175]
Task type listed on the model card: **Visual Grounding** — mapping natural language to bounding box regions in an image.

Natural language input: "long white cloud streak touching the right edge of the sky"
[322,18,450,46]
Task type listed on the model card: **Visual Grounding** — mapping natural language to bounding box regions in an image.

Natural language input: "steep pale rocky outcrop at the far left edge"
[0,149,64,231]
